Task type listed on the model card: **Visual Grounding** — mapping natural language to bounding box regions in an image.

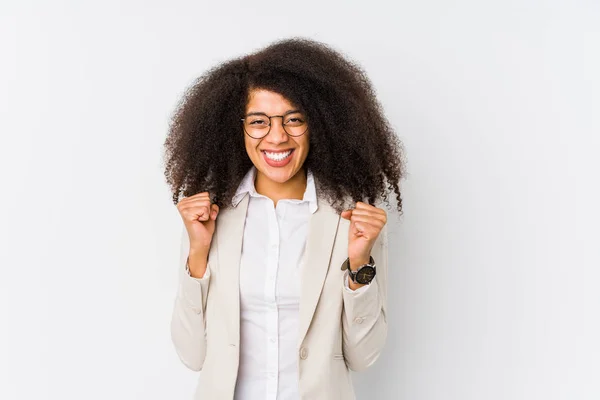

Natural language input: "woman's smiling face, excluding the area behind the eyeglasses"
[244,89,309,183]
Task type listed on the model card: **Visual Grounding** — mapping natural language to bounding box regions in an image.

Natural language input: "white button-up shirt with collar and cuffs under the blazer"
[191,166,370,400]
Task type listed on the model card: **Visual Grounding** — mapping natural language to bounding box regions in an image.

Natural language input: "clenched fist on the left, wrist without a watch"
[177,192,219,257]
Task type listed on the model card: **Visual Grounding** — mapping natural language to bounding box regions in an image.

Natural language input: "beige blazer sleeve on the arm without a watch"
[171,228,211,371]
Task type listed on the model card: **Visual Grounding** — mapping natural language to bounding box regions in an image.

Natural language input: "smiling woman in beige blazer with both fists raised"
[165,38,404,400]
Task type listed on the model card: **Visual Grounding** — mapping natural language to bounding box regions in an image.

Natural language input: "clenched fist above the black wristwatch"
[341,201,387,270]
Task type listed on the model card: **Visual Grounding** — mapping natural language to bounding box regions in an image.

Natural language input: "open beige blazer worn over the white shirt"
[171,194,388,400]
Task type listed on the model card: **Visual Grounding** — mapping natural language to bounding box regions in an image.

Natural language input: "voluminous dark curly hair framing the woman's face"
[164,38,405,215]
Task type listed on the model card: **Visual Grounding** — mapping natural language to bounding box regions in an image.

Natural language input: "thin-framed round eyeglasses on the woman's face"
[241,110,308,139]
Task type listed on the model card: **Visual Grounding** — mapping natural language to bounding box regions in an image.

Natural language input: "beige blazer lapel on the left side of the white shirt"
[215,193,250,346]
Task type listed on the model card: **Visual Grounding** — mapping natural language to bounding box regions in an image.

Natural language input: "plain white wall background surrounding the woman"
[0,0,600,400]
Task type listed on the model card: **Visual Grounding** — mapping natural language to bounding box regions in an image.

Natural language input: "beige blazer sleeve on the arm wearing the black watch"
[342,224,388,371]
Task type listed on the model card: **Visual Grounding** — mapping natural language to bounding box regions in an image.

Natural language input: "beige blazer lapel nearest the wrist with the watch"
[298,197,340,347]
